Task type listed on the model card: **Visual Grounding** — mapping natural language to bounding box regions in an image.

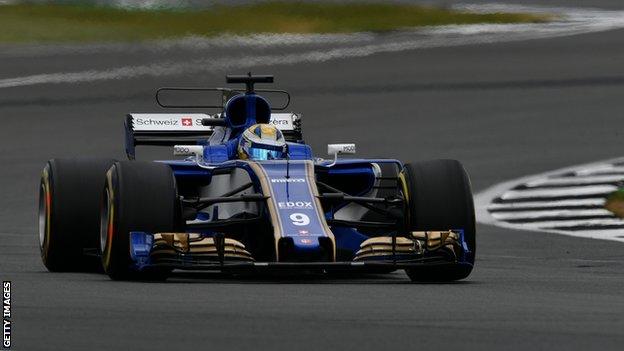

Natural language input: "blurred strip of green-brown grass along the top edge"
[0,1,549,43]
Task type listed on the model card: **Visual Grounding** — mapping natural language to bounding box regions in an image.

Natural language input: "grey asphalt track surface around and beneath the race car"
[0,1,624,350]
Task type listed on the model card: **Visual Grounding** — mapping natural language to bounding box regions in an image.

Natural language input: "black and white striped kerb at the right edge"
[475,158,624,242]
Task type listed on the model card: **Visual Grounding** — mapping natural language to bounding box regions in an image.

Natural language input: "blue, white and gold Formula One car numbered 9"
[39,74,476,281]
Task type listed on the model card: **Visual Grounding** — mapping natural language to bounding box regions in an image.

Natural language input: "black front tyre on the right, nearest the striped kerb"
[400,160,476,281]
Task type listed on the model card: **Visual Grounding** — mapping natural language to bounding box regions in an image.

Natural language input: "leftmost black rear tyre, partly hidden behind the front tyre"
[39,159,115,272]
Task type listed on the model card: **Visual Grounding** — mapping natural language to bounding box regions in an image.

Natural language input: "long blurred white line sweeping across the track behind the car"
[0,5,624,88]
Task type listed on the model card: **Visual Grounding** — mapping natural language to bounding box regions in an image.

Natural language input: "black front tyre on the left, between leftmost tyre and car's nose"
[100,161,180,280]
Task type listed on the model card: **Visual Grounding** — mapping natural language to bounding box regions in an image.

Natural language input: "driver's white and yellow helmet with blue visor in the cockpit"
[238,123,287,160]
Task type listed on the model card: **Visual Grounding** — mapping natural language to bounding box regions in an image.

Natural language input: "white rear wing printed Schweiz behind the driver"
[125,113,303,160]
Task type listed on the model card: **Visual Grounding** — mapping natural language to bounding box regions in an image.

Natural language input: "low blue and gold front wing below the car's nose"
[130,230,472,272]
